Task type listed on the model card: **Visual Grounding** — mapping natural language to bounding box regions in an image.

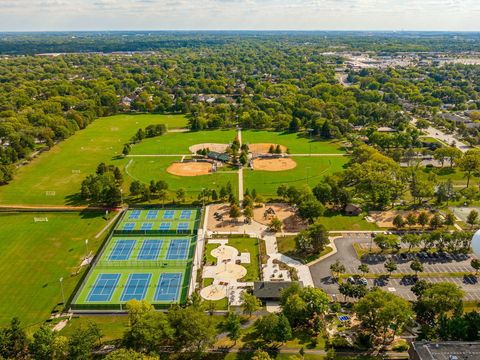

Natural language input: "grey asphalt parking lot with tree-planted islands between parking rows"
[310,233,480,301]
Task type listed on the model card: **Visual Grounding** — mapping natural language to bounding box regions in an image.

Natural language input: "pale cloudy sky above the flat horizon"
[0,0,480,31]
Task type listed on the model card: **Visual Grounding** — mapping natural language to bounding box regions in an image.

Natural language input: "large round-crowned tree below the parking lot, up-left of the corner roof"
[355,289,413,340]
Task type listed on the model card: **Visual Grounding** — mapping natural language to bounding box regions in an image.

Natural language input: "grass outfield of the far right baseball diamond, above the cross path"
[242,130,344,154]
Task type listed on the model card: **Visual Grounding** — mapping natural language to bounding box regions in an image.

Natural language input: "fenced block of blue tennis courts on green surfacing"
[72,209,200,310]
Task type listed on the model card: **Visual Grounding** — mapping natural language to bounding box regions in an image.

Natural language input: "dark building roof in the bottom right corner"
[412,341,480,360]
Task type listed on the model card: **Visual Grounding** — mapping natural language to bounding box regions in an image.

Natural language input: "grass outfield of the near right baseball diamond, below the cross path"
[243,156,348,198]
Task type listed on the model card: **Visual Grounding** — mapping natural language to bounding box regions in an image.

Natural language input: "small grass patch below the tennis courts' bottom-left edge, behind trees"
[60,315,128,341]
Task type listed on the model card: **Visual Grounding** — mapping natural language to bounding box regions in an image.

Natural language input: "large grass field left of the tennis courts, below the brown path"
[0,212,107,326]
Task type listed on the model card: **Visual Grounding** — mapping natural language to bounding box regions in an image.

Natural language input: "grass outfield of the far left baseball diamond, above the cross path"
[131,130,236,155]
